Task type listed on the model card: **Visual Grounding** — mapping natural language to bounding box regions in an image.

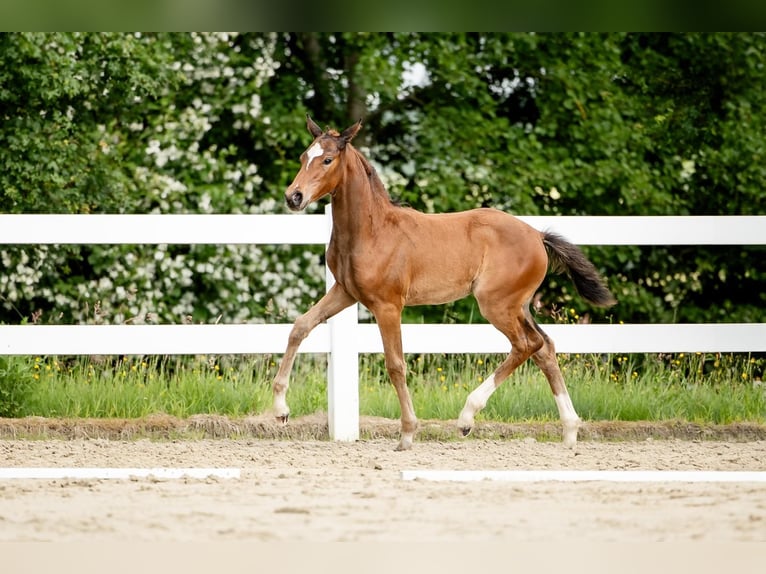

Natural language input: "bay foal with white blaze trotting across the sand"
[273,116,615,450]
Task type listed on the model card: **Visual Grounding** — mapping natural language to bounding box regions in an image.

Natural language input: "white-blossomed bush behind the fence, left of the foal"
[0,34,324,323]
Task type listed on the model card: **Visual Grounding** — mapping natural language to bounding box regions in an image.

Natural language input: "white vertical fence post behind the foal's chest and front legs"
[325,205,359,441]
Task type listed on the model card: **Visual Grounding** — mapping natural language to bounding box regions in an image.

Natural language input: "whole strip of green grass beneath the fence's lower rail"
[0,354,766,424]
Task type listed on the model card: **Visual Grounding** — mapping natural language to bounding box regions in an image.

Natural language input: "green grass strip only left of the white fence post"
[19,355,327,418]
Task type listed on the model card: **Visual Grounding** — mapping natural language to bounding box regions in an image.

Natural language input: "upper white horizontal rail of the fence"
[0,214,766,245]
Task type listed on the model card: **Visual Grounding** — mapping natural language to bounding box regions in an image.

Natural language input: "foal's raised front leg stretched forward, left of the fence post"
[272,283,356,423]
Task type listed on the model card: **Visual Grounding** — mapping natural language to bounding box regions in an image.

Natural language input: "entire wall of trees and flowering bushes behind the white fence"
[0,33,766,328]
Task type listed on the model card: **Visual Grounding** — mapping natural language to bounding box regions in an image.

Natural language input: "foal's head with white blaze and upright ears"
[285,115,362,211]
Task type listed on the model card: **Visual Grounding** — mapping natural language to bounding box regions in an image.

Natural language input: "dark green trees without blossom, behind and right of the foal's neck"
[277,34,766,321]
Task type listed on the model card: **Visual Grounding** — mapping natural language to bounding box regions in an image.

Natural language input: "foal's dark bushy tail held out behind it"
[543,231,617,307]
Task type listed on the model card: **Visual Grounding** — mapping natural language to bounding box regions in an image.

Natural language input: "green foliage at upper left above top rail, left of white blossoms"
[0,33,182,213]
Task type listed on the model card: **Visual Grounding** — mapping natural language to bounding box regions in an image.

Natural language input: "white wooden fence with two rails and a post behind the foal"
[0,209,766,440]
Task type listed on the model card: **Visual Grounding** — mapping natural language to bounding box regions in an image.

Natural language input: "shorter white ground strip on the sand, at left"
[0,467,240,479]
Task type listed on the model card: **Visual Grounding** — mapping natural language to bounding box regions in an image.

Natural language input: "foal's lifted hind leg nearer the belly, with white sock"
[457,310,544,436]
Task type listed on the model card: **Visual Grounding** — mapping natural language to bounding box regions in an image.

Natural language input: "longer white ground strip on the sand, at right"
[402,470,766,482]
